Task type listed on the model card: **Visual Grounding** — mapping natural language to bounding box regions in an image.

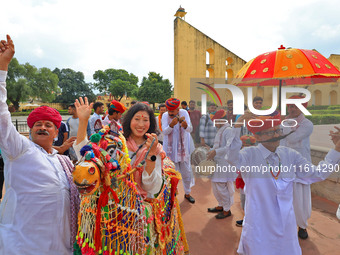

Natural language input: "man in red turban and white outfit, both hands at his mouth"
[162,98,195,204]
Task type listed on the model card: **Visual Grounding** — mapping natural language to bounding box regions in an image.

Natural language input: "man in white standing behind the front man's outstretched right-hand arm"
[280,96,313,239]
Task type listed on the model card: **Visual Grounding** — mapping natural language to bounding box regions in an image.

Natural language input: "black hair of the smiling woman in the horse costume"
[123,104,156,139]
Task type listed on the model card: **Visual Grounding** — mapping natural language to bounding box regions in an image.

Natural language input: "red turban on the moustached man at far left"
[27,106,62,128]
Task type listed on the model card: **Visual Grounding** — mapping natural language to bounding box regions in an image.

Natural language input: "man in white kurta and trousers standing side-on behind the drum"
[207,114,237,219]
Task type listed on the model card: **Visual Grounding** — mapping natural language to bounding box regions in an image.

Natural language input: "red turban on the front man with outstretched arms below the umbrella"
[247,111,281,134]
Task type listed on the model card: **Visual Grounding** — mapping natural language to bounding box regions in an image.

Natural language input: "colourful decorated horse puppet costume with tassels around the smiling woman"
[73,126,188,255]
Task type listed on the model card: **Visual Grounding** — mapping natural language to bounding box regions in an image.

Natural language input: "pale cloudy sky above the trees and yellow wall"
[0,0,340,84]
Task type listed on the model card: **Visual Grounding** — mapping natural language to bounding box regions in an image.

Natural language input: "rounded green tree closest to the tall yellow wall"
[137,72,172,109]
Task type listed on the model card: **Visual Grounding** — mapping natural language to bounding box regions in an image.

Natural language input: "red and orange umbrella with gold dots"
[233,45,340,108]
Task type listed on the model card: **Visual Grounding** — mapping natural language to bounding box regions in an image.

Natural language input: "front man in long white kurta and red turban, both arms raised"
[226,112,340,255]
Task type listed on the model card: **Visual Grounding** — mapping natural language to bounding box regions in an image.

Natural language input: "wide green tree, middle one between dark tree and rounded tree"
[93,69,138,101]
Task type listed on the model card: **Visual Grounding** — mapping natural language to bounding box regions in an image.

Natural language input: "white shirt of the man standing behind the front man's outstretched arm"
[280,114,313,161]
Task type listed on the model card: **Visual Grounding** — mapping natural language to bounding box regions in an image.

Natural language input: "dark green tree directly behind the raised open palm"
[53,68,96,104]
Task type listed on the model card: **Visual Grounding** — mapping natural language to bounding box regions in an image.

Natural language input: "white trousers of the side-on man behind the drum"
[211,181,235,212]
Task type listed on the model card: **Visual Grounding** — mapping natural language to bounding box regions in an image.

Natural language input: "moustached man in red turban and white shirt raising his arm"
[0,36,80,255]
